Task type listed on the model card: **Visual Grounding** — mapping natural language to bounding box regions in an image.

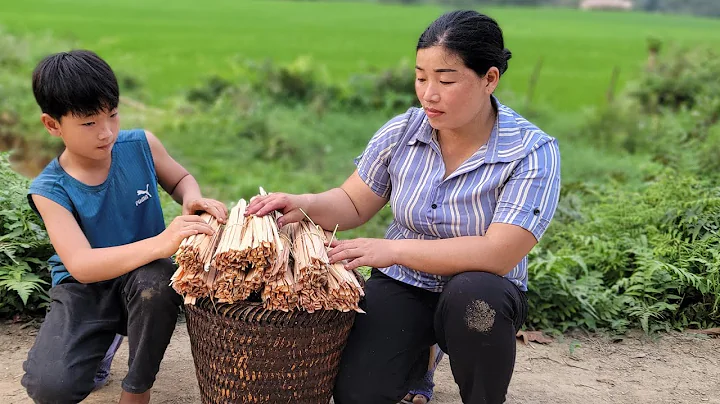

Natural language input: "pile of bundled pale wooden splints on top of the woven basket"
[170,188,363,312]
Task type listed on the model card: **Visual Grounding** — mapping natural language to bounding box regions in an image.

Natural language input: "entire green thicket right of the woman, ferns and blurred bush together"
[529,49,720,332]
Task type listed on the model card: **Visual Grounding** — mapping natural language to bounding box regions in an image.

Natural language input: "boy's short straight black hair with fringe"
[33,50,120,121]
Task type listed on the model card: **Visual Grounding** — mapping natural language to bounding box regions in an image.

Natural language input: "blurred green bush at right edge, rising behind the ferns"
[577,49,720,176]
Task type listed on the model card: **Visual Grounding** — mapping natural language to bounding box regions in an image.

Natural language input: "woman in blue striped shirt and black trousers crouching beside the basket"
[248,11,560,404]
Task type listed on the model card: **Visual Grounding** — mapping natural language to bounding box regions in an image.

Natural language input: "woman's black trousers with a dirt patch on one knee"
[333,269,527,404]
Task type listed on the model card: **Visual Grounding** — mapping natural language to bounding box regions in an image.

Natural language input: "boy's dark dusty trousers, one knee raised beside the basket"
[21,259,182,404]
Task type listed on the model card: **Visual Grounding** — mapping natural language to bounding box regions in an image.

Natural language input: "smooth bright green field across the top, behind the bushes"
[0,0,720,111]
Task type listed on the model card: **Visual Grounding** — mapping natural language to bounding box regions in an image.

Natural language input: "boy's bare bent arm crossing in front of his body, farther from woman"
[32,195,213,283]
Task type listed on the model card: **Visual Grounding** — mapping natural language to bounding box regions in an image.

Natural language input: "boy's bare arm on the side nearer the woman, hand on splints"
[145,131,228,223]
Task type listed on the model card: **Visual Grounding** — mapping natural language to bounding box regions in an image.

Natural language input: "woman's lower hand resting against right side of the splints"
[328,238,396,270]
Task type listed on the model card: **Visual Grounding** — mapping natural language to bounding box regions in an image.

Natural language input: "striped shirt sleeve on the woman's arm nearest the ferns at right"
[492,139,560,241]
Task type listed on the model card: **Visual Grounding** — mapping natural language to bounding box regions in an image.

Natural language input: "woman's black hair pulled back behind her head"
[416,10,512,77]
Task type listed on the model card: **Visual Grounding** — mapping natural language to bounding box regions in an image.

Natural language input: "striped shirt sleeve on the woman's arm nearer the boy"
[355,111,412,198]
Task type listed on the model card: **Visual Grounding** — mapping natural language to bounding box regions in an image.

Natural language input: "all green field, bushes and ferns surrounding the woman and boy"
[0,4,720,332]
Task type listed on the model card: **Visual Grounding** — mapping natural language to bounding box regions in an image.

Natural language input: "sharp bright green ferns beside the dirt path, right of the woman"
[529,174,720,332]
